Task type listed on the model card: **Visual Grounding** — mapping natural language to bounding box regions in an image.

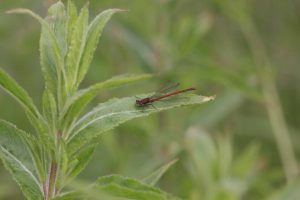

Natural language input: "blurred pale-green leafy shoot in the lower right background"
[185,127,261,200]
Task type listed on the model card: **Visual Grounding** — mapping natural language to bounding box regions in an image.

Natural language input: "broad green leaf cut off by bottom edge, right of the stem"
[95,175,179,200]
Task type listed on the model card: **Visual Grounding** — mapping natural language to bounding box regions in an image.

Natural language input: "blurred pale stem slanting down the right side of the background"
[239,17,299,182]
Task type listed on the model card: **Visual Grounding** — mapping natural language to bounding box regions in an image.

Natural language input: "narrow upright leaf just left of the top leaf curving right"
[66,4,89,94]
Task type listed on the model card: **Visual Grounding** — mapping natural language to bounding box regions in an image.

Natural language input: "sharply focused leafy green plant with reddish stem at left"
[0,1,213,200]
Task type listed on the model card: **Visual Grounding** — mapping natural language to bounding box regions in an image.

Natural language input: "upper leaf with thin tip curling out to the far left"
[7,8,63,99]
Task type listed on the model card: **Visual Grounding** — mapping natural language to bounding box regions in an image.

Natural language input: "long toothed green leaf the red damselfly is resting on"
[68,94,214,154]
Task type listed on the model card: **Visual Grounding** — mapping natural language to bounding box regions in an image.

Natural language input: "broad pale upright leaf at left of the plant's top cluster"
[44,1,68,104]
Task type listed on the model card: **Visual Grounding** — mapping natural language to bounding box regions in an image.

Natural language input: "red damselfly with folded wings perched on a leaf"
[135,83,196,107]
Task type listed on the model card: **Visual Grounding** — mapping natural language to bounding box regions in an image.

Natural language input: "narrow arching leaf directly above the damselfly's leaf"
[62,74,152,128]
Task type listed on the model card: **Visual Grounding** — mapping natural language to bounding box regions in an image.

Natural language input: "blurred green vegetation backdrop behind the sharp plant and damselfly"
[0,0,300,200]
